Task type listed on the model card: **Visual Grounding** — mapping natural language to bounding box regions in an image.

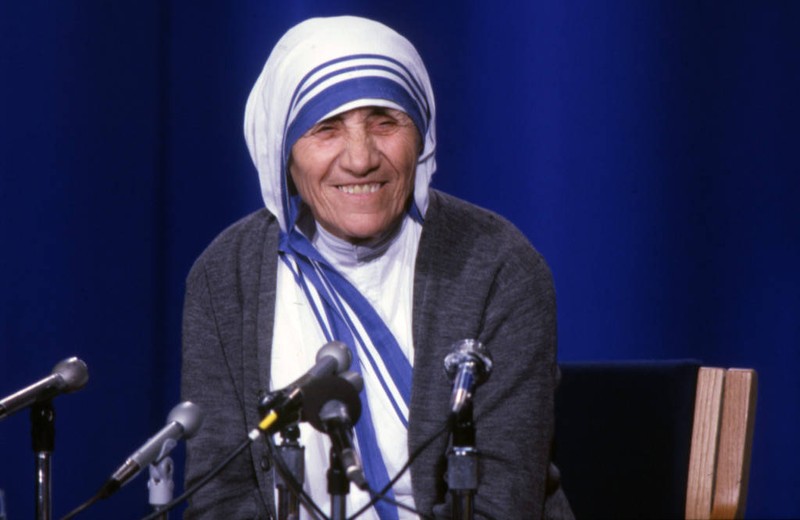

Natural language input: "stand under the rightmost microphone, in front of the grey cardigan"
[447,401,478,520]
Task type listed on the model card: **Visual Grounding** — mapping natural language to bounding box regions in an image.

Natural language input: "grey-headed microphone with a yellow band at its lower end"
[258,341,353,431]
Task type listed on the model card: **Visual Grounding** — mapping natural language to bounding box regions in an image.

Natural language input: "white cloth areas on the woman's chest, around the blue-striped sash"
[270,218,422,519]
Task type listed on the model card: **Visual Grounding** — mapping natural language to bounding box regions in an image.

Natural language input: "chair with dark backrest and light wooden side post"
[554,360,757,519]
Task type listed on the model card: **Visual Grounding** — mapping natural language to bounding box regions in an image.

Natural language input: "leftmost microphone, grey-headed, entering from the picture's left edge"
[0,357,89,420]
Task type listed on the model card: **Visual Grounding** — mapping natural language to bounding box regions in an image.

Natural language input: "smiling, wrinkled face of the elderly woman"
[289,107,421,244]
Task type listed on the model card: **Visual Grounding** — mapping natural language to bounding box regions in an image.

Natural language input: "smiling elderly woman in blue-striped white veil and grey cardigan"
[182,17,571,519]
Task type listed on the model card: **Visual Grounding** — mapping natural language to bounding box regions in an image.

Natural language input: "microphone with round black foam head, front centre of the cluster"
[303,372,368,489]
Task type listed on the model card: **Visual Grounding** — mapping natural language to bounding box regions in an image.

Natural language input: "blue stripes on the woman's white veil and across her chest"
[280,55,430,520]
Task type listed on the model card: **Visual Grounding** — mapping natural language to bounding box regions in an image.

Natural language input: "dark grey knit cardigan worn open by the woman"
[182,190,572,519]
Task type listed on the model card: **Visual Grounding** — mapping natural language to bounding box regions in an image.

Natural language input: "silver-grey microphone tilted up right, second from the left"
[99,401,203,498]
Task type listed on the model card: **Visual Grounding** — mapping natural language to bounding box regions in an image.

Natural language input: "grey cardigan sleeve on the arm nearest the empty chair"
[468,246,572,519]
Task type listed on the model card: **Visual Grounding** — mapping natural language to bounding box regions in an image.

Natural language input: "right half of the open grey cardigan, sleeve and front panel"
[410,194,572,519]
